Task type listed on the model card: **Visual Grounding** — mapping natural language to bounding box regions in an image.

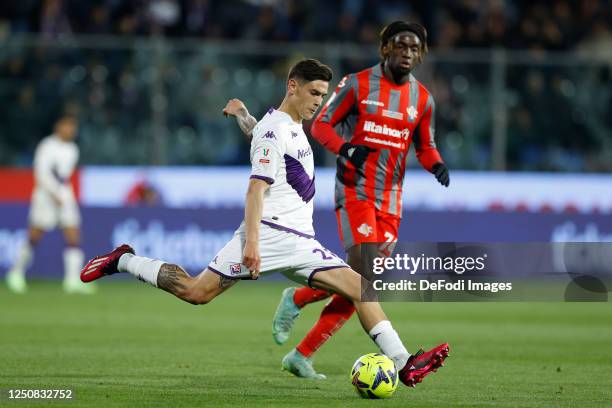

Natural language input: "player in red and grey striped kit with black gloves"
[224,21,450,379]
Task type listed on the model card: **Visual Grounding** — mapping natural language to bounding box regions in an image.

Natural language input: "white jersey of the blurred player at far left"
[34,135,79,201]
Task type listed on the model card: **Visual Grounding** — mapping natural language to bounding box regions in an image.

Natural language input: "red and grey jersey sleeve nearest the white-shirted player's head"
[311,74,357,154]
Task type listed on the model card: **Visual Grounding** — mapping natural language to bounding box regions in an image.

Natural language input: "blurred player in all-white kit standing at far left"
[6,116,95,294]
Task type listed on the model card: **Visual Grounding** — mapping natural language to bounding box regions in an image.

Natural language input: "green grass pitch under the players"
[0,278,612,407]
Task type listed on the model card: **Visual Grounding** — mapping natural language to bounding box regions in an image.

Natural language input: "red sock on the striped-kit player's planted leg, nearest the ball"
[296,291,355,357]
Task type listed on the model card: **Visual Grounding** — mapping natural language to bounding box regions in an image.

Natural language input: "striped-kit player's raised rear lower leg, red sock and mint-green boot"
[272,287,330,345]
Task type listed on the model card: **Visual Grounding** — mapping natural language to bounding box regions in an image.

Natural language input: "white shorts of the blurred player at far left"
[28,190,81,231]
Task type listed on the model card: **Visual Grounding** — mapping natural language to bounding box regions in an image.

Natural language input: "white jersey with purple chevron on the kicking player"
[251,109,315,236]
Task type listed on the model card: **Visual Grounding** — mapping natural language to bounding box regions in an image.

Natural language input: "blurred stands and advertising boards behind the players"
[0,0,612,276]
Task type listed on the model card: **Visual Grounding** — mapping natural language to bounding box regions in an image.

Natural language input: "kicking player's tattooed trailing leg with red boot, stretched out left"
[81,244,238,305]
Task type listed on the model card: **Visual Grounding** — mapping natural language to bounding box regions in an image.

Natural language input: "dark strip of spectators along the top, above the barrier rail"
[0,0,612,50]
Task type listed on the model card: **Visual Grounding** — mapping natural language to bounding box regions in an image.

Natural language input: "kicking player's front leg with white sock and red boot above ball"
[312,268,450,387]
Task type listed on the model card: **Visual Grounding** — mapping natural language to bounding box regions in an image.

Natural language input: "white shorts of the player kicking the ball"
[208,223,349,286]
